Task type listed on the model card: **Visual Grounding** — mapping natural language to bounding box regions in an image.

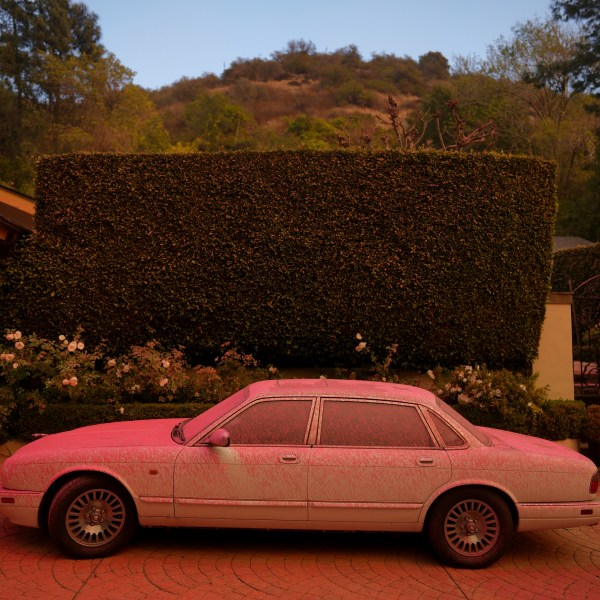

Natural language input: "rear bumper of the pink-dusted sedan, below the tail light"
[517,499,600,531]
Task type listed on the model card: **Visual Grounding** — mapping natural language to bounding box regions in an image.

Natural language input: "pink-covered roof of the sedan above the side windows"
[248,378,435,406]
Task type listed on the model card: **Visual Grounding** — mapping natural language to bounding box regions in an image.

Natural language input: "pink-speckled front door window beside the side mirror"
[222,399,312,446]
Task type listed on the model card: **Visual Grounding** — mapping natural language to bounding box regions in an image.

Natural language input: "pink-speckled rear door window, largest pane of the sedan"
[320,400,434,448]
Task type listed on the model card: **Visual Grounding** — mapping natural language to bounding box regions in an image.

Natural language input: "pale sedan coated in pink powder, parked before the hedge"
[0,379,600,568]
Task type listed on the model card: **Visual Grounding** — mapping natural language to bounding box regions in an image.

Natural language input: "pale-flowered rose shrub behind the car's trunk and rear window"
[427,365,547,434]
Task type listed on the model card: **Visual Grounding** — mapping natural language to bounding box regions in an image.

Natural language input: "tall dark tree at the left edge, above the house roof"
[0,0,103,192]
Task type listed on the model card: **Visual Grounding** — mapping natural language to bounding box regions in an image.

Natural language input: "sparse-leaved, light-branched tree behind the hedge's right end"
[452,20,597,235]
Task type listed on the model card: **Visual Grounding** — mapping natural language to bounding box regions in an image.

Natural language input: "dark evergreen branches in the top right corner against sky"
[552,0,600,93]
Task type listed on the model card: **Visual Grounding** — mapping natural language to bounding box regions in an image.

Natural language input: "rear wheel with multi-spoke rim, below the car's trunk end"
[427,489,514,569]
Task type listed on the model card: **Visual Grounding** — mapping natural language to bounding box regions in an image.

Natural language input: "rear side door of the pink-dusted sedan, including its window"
[308,398,451,524]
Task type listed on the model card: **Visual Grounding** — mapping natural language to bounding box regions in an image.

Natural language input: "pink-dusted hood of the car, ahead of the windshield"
[19,419,182,456]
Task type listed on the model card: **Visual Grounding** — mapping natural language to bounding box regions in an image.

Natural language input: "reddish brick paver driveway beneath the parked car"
[0,520,600,600]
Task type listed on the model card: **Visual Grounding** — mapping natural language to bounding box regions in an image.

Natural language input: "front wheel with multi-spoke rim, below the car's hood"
[48,475,137,558]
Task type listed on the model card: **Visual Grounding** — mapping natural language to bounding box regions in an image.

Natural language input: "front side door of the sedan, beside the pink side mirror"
[174,398,315,524]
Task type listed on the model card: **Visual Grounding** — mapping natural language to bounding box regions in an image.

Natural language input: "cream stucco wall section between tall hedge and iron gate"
[533,292,575,400]
